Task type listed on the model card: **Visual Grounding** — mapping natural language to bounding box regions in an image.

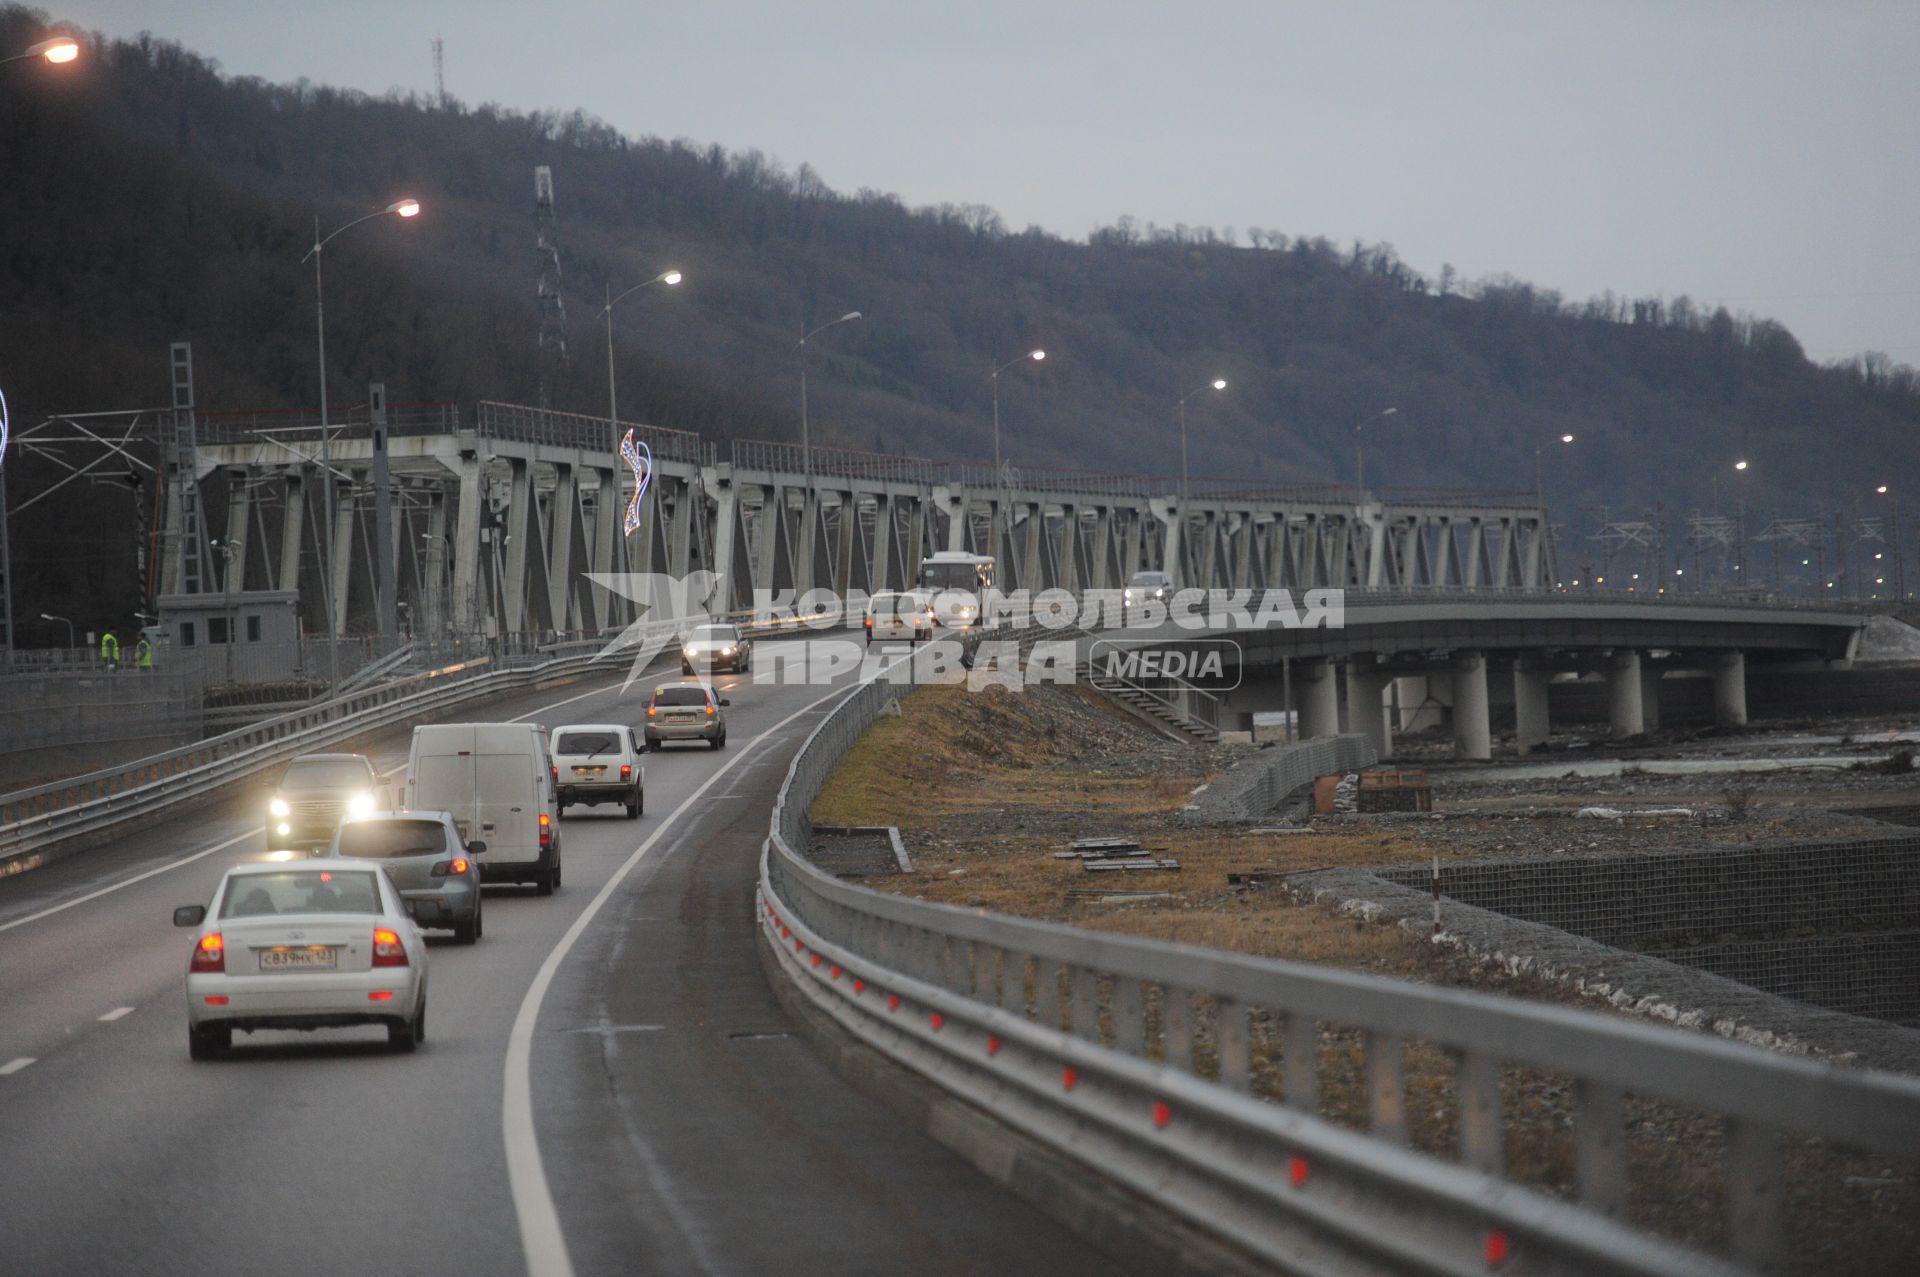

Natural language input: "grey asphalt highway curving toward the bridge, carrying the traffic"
[0,643,1117,1277]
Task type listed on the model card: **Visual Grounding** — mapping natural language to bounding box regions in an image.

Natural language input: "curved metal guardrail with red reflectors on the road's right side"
[755,668,1920,1275]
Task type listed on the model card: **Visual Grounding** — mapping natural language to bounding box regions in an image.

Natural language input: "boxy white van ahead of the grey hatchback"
[407,722,561,895]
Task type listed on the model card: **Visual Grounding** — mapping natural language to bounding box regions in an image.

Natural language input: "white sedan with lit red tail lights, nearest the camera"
[173,860,426,1060]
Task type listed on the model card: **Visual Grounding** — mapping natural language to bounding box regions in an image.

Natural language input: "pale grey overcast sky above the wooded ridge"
[40,0,1920,365]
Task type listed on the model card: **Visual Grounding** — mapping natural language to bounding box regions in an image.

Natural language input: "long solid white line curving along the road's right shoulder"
[501,672,879,1277]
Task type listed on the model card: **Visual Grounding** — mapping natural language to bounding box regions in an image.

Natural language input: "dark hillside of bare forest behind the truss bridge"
[0,8,1920,633]
